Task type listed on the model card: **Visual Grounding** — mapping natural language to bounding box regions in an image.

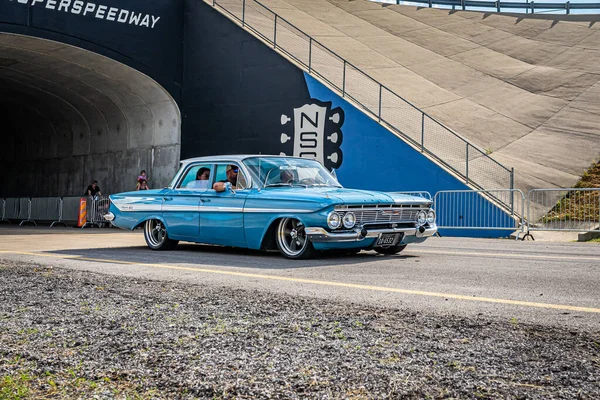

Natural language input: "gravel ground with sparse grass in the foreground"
[0,259,600,399]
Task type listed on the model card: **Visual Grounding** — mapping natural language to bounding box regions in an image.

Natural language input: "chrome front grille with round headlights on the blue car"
[336,204,429,225]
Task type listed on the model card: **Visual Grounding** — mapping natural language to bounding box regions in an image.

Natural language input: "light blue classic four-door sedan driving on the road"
[105,155,437,258]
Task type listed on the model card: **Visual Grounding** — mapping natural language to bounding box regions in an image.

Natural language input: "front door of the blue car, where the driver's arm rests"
[200,162,250,247]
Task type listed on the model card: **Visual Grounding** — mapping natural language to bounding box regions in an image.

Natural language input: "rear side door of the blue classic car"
[162,164,213,242]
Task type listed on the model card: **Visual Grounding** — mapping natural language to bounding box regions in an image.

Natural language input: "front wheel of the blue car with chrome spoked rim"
[275,218,316,259]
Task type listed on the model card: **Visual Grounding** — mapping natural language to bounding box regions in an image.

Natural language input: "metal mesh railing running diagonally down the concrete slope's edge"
[204,0,514,189]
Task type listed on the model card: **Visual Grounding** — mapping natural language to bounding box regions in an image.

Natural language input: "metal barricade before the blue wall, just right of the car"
[433,189,525,239]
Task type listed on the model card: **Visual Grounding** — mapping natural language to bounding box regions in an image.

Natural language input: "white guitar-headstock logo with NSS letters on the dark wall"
[280,99,344,170]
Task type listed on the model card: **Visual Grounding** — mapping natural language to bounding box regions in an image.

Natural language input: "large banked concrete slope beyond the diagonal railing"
[254,0,600,191]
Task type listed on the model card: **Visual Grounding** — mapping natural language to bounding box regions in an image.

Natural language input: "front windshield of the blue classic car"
[243,157,341,188]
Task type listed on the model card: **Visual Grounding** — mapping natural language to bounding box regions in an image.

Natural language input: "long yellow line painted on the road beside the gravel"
[7,251,600,313]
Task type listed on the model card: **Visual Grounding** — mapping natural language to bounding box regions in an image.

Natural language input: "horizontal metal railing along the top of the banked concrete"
[386,0,600,14]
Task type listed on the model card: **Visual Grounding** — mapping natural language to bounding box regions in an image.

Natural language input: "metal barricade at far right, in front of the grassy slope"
[527,188,600,232]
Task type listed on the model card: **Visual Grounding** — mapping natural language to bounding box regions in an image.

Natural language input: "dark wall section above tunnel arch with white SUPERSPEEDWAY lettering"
[0,0,184,101]
